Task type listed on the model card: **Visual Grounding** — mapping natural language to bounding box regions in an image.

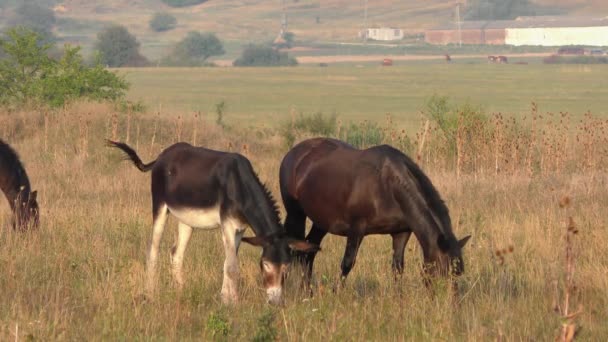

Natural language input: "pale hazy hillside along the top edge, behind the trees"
[4,0,608,58]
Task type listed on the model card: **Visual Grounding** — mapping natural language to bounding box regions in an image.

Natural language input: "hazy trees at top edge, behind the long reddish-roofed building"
[465,0,537,20]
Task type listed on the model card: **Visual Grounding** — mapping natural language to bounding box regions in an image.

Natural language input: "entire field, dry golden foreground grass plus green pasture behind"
[0,64,608,341]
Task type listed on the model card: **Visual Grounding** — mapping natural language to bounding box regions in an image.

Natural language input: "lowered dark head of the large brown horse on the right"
[425,234,471,276]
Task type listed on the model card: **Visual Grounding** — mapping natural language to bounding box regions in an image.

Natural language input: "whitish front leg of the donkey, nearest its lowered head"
[221,220,244,304]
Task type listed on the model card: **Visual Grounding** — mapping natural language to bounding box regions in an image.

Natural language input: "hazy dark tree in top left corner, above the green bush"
[9,0,56,42]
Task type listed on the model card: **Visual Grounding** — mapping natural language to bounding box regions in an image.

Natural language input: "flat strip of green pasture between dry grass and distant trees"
[120,61,608,126]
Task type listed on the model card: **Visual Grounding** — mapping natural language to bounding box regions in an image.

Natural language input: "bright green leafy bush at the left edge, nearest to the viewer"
[0,28,128,107]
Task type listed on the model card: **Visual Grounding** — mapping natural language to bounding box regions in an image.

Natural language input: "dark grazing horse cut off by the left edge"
[0,140,40,231]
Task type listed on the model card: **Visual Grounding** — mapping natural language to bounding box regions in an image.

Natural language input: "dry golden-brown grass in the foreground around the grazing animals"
[0,104,608,341]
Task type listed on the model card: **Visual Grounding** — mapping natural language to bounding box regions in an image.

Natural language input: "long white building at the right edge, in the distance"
[505,17,608,46]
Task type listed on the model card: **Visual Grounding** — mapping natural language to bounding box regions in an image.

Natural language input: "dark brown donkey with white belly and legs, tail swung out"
[107,140,317,304]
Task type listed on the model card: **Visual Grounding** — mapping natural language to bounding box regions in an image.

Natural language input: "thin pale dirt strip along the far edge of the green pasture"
[214,52,550,66]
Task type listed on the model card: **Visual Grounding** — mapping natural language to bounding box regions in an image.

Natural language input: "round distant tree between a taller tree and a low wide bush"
[168,31,225,66]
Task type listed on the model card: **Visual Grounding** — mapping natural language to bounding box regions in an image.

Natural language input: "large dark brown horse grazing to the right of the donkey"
[279,138,470,286]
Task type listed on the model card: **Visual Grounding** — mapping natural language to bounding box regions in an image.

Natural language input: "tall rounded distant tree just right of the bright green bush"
[95,25,148,67]
